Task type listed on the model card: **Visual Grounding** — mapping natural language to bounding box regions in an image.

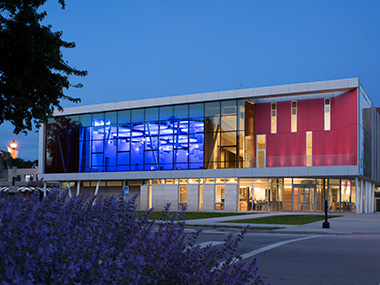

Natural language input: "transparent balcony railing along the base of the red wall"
[244,154,356,168]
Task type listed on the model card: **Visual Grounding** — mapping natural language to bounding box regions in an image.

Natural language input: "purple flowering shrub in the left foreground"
[0,192,262,284]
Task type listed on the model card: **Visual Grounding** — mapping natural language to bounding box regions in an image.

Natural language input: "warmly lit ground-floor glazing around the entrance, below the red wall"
[233,178,356,212]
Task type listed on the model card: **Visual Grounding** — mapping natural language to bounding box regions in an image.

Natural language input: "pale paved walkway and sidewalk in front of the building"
[186,212,380,236]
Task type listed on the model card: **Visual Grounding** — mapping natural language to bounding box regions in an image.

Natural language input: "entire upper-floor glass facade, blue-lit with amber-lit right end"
[45,100,253,173]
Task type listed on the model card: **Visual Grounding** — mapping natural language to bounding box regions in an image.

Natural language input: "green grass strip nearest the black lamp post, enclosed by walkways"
[228,215,342,225]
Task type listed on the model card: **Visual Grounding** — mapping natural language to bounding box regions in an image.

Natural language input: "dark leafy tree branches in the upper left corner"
[0,0,87,134]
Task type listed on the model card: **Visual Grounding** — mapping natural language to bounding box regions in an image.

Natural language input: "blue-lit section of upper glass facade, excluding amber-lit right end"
[49,103,208,172]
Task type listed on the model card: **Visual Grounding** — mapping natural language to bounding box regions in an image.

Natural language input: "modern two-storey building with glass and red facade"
[39,78,380,213]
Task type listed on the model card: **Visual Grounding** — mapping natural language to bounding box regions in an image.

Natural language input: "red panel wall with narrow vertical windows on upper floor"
[255,90,357,167]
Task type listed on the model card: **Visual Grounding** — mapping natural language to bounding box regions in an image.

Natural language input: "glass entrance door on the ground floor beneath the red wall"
[293,185,316,212]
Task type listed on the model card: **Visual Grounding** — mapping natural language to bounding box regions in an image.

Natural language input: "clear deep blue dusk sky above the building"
[0,0,380,160]
